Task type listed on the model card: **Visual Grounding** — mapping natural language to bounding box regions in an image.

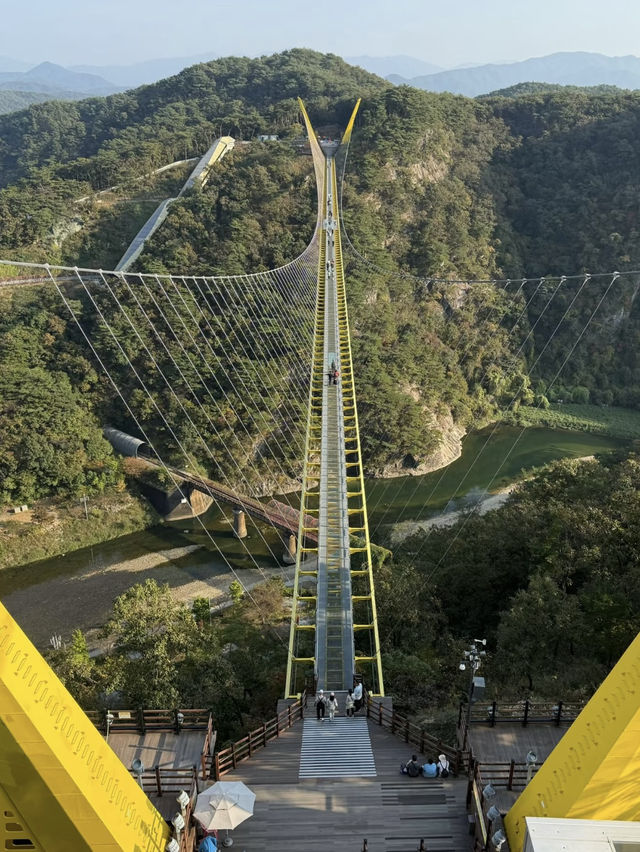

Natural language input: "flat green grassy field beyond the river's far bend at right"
[504,403,640,440]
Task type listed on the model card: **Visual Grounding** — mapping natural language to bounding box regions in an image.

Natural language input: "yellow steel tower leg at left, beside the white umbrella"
[0,604,170,852]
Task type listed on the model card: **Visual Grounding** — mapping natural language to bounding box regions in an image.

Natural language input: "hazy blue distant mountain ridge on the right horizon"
[387,52,640,98]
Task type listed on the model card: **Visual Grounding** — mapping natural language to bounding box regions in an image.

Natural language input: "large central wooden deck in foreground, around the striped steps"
[209,721,472,852]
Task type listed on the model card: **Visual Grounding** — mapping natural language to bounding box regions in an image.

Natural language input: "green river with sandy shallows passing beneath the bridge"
[0,426,623,644]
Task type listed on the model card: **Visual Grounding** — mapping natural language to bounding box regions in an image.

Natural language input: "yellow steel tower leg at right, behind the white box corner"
[505,634,640,852]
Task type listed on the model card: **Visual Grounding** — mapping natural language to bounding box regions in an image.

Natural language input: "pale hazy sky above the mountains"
[5,0,640,67]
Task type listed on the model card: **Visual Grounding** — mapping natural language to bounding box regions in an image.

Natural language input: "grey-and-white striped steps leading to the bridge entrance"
[298,702,376,779]
